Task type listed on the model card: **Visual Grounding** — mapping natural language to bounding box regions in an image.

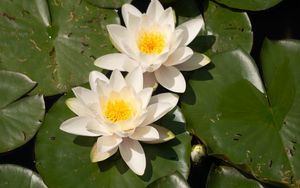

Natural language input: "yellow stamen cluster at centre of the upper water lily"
[138,31,165,54]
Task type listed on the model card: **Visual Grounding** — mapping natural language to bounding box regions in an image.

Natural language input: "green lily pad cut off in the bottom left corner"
[0,164,47,188]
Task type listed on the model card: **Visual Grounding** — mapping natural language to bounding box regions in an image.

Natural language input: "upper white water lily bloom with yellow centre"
[95,0,210,93]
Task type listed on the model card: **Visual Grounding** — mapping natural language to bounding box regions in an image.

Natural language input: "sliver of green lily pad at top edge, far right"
[216,0,282,11]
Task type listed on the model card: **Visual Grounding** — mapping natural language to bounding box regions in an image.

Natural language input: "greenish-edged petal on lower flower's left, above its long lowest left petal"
[66,98,95,117]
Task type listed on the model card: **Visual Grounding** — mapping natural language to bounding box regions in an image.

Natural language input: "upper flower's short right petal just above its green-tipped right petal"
[164,47,193,66]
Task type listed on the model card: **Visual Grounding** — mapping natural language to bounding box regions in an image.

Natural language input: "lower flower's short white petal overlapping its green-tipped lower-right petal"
[130,126,159,141]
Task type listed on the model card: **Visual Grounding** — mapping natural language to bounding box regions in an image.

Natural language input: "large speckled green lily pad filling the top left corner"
[0,0,119,96]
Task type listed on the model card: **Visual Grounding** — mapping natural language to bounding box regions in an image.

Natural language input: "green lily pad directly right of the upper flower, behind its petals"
[204,1,253,53]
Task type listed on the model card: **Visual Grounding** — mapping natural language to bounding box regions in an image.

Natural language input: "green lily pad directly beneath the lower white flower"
[35,95,191,188]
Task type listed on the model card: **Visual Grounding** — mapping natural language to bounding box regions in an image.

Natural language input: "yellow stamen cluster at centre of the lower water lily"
[104,99,134,123]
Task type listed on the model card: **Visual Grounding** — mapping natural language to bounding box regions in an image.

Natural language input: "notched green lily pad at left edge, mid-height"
[0,70,45,153]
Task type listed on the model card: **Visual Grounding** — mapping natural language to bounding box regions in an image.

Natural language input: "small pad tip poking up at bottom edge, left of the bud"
[147,172,190,188]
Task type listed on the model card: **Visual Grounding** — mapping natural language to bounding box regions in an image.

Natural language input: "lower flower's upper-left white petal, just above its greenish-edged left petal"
[72,87,98,105]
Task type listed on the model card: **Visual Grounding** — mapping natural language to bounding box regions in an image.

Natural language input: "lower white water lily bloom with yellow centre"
[60,68,178,175]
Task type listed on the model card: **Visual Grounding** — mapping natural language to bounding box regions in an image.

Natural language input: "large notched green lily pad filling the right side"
[182,44,300,187]
